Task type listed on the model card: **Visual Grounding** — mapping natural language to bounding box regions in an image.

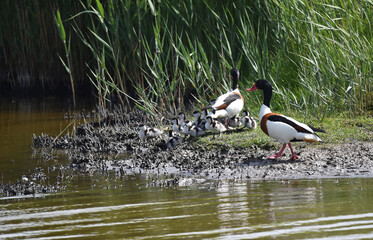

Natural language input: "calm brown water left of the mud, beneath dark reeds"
[0,97,93,183]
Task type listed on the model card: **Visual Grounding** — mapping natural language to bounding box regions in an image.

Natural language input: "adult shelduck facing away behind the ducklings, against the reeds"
[209,68,244,128]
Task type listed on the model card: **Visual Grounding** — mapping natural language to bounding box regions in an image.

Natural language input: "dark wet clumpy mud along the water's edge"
[0,109,373,196]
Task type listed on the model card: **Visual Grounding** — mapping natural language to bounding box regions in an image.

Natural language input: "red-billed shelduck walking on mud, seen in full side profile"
[247,79,326,160]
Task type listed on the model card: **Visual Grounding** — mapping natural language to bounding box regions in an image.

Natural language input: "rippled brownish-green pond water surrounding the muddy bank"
[0,96,373,239]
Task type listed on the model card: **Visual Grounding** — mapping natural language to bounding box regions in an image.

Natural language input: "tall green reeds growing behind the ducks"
[0,0,373,118]
